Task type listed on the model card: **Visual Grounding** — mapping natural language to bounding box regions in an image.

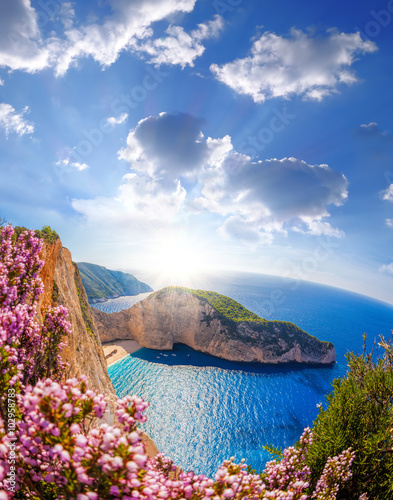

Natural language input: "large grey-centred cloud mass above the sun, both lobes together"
[73,113,348,245]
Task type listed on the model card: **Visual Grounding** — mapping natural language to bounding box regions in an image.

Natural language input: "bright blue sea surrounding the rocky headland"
[102,273,393,476]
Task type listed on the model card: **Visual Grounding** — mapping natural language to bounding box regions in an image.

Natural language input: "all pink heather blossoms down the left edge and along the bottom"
[0,227,364,500]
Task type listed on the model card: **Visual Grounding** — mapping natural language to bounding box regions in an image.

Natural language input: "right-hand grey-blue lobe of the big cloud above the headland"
[192,157,348,237]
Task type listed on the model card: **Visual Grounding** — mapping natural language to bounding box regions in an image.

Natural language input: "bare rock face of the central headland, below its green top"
[91,290,336,364]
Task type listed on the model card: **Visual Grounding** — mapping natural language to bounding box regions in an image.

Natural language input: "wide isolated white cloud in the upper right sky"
[210,29,377,102]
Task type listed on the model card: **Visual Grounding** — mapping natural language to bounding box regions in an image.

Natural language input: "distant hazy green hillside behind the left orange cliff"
[77,262,153,304]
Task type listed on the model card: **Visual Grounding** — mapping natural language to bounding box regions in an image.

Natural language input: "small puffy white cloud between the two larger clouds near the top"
[135,16,224,68]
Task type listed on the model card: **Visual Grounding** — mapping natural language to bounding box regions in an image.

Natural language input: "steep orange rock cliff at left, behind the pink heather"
[39,239,116,424]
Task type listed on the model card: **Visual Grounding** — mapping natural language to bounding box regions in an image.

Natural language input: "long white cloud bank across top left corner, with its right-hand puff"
[0,0,223,76]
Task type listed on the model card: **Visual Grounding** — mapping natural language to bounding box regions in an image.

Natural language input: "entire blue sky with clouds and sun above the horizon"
[0,0,393,303]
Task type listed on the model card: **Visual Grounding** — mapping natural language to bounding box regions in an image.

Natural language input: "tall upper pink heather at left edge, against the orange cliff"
[0,226,71,410]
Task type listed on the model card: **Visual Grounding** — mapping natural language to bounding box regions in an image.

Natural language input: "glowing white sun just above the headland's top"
[151,232,209,286]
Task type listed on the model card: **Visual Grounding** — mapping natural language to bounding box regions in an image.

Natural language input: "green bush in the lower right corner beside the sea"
[307,337,393,500]
